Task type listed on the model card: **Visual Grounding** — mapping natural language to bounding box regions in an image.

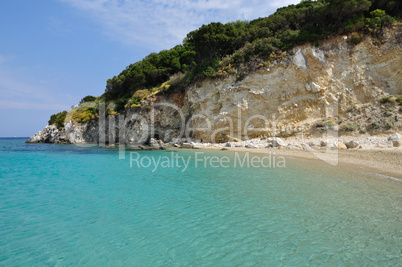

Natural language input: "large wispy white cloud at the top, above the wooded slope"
[60,0,300,50]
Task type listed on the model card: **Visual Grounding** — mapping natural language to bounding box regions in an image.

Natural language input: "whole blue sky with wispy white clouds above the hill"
[0,0,299,137]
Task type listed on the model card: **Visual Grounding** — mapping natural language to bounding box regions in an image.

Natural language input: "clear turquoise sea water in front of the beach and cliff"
[0,139,402,266]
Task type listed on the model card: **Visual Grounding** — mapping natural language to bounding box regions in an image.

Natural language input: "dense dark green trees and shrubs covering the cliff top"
[48,0,402,127]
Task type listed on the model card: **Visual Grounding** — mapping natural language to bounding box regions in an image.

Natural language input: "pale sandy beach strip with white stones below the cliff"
[24,133,402,182]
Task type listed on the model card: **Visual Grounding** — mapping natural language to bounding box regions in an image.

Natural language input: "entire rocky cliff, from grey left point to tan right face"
[28,26,402,146]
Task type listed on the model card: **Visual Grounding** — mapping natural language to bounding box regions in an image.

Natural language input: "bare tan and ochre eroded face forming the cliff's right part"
[187,29,402,142]
